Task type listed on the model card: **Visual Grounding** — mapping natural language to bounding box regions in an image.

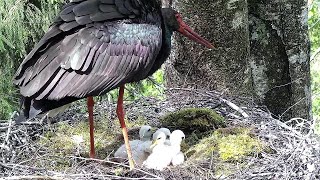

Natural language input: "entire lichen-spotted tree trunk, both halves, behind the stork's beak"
[166,0,312,119]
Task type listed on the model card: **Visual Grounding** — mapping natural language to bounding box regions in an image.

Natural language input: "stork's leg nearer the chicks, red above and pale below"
[117,85,134,170]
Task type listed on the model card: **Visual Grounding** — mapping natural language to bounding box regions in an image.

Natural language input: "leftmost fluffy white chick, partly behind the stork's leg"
[114,125,152,165]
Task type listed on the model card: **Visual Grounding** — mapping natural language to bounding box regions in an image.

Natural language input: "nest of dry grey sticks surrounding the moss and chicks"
[0,89,320,179]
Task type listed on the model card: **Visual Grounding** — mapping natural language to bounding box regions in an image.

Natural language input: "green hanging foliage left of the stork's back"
[0,0,63,119]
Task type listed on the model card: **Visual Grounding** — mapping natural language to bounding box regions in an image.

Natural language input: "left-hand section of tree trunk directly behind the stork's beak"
[166,0,252,95]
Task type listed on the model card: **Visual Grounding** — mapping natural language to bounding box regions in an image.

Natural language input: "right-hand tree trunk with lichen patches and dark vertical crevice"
[249,0,312,119]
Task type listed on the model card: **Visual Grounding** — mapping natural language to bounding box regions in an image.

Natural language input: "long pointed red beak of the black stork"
[177,17,214,49]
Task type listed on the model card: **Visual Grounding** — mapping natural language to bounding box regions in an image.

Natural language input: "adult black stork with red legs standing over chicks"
[14,0,213,168]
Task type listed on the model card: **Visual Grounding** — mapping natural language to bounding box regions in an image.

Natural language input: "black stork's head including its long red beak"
[161,7,214,49]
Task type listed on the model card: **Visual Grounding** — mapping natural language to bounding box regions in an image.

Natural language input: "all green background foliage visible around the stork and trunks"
[0,0,320,124]
